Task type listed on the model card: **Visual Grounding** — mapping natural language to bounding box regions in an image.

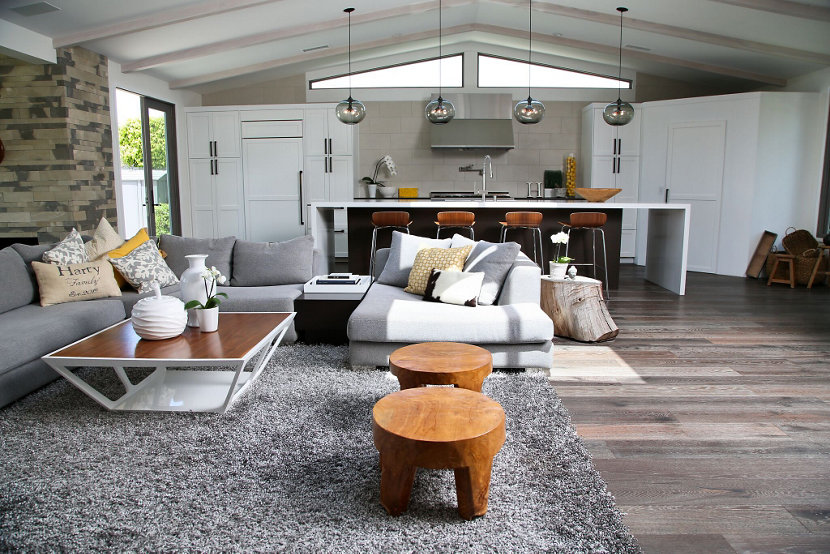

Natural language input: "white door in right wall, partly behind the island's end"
[666,121,726,273]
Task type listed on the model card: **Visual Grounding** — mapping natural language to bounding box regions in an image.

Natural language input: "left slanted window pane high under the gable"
[311,54,464,90]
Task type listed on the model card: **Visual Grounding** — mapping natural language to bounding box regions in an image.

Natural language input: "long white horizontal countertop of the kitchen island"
[309,199,689,210]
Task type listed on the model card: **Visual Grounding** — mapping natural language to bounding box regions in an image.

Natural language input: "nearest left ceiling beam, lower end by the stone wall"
[52,0,283,48]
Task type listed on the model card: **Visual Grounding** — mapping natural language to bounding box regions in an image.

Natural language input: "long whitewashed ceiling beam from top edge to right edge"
[491,0,830,65]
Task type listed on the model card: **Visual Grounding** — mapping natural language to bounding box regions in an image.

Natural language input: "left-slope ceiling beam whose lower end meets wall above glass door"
[121,0,475,73]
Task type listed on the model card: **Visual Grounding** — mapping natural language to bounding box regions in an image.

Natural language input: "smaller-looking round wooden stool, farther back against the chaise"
[389,342,493,392]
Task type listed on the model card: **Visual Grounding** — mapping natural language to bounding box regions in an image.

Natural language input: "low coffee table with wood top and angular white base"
[43,312,296,413]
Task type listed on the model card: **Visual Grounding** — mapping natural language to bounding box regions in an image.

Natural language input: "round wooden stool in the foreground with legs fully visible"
[372,387,506,519]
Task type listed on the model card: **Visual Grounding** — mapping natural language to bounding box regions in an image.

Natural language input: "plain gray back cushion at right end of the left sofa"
[231,235,314,287]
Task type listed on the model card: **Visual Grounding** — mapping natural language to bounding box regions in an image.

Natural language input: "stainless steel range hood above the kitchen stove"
[430,94,516,150]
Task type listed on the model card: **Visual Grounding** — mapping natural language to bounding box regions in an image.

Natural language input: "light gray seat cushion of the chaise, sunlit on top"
[348,283,553,344]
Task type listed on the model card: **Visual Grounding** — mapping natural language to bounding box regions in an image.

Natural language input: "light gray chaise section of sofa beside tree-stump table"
[348,248,553,368]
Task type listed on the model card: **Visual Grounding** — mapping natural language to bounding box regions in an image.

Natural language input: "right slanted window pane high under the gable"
[478,54,631,89]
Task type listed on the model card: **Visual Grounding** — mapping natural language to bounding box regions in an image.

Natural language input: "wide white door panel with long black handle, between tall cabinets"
[242,138,305,241]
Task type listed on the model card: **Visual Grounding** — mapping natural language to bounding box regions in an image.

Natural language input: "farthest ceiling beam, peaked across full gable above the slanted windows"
[170,23,787,89]
